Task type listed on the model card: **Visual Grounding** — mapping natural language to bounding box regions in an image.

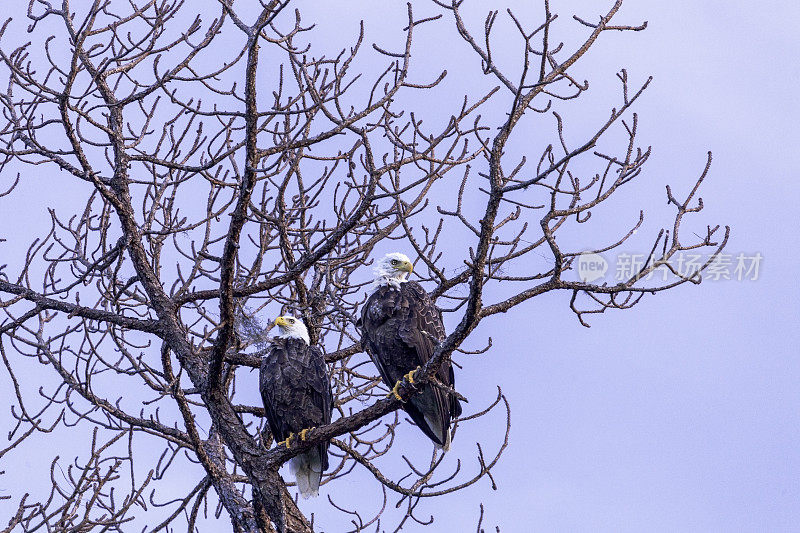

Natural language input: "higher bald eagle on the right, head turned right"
[361,253,461,451]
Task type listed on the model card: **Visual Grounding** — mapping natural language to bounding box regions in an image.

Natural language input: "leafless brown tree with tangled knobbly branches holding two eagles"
[0,0,728,532]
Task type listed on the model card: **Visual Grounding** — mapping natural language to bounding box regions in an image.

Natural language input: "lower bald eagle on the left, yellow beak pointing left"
[259,316,333,498]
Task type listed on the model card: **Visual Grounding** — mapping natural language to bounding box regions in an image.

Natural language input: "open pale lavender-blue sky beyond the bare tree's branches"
[0,0,800,532]
